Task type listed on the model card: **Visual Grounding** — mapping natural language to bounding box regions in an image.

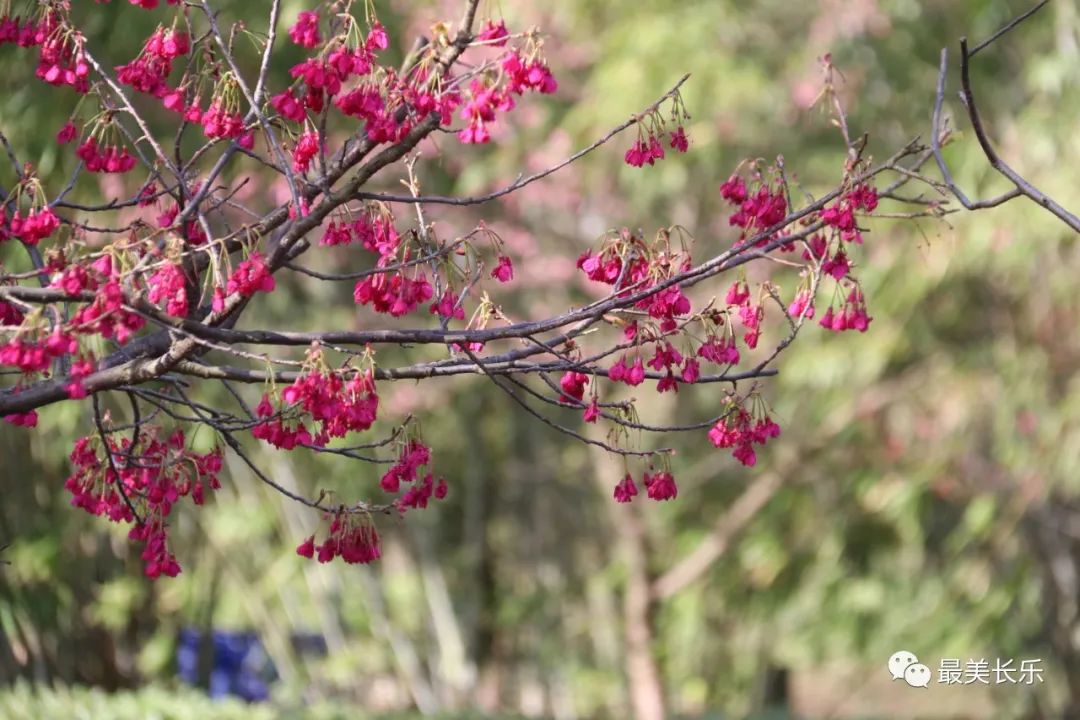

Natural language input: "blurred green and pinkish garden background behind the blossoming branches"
[0,0,1080,720]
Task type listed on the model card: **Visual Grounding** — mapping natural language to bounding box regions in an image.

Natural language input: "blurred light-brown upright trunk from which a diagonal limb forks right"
[590,437,666,720]
